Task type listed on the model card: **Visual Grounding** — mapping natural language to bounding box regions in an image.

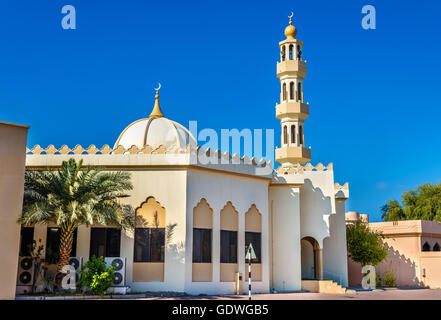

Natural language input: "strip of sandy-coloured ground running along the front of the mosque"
[137,289,441,300]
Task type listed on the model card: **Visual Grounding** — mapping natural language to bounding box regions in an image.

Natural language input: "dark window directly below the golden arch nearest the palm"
[134,228,165,262]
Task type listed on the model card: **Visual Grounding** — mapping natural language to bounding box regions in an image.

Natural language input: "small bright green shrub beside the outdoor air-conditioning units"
[79,256,115,295]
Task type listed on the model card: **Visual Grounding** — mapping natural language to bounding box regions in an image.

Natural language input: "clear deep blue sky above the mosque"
[0,0,441,221]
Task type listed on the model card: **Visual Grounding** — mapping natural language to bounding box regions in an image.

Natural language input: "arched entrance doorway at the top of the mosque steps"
[300,237,323,280]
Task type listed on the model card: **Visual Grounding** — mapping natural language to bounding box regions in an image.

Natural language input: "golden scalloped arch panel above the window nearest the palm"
[135,197,165,228]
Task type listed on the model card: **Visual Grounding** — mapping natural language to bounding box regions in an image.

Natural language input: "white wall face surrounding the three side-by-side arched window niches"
[185,170,270,294]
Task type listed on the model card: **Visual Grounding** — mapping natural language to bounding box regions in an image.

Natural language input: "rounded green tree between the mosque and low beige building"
[346,221,387,266]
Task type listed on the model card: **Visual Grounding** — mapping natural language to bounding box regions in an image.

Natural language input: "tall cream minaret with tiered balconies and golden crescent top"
[276,14,311,167]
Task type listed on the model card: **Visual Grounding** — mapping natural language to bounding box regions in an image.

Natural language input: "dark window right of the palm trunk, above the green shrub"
[89,228,121,257]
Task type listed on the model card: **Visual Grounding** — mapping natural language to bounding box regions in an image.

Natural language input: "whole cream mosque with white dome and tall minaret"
[22,17,349,294]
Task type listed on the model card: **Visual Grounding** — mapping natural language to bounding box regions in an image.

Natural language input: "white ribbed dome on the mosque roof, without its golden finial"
[115,117,197,151]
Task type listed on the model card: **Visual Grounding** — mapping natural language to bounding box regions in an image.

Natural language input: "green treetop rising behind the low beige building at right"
[381,183,441,221]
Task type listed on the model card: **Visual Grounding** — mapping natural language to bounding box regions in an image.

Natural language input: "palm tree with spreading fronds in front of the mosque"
[18,159,135,273]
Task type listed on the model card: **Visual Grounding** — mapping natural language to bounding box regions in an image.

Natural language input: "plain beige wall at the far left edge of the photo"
[0,122,28,299]
